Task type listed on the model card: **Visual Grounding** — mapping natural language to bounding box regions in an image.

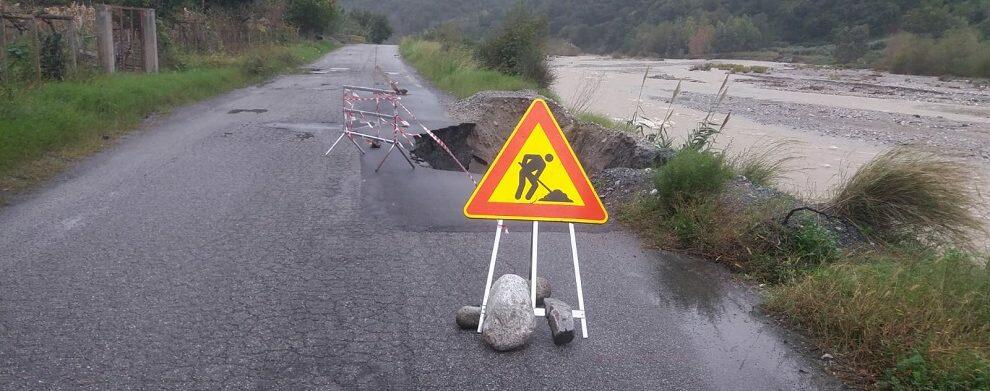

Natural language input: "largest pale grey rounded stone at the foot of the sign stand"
[481,274,536,351]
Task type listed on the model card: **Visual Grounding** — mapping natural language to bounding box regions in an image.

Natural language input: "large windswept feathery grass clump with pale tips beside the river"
[829,147,982,243]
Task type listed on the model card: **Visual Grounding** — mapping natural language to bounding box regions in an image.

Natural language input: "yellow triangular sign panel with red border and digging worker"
[464,99,608,224]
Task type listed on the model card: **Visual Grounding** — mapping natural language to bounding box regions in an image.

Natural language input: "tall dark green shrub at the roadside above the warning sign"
[477,4,553,87]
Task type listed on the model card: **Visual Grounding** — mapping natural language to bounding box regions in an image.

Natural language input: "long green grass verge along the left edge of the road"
[0,43,332,194]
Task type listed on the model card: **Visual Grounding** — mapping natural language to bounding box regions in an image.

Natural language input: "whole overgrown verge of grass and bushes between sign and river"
[618,149,990,390]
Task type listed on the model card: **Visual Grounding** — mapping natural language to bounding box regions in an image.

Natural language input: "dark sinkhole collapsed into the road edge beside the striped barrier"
[412,122,488,171]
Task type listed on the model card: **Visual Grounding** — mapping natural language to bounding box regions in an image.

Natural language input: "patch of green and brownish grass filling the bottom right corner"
[766,249,990,390]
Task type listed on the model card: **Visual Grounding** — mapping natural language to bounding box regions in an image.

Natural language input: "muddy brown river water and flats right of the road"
[552,56,990,233]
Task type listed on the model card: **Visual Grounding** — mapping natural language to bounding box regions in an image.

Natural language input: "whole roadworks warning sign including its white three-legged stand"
[464,99,608,338]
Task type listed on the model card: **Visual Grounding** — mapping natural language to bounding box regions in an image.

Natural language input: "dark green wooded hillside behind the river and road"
[342,0,990,56]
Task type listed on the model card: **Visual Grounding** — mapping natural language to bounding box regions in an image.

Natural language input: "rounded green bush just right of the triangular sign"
[653,149,732,211]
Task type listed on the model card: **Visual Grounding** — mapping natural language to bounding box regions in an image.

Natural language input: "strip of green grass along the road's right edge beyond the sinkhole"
[399,38,559,100]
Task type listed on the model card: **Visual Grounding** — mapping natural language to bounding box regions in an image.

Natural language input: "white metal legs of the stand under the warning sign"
[478,220,588,338]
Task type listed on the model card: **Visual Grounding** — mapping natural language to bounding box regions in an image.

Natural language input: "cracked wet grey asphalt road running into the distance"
[0,45,841,390]
